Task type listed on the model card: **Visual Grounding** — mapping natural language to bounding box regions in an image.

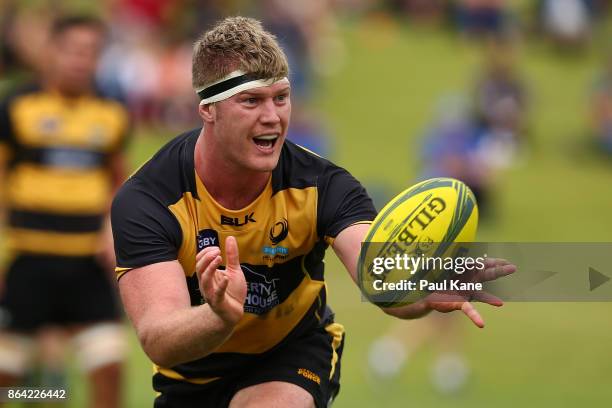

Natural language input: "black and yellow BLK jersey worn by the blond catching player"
[111,130,376,384]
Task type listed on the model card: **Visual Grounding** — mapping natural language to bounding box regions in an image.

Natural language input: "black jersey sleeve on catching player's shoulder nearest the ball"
[317,166,376,239]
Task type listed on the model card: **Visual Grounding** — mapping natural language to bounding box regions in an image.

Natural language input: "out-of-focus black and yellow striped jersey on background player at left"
[0,85,129,256]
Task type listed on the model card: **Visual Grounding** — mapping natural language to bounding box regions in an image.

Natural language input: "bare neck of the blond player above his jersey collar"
[194,135,271,210]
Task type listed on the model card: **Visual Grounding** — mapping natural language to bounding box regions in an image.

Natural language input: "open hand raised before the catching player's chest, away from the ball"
[196,236,247,326]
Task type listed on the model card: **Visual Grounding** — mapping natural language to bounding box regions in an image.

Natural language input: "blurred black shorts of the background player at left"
[0,255,121,334]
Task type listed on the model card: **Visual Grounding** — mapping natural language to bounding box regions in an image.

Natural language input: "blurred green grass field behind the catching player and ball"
[56,18,612,408]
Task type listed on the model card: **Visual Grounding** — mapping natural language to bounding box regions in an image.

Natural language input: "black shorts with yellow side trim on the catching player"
[153,323,344,408]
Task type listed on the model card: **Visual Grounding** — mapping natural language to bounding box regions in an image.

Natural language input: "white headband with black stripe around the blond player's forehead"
[196,70,289,105]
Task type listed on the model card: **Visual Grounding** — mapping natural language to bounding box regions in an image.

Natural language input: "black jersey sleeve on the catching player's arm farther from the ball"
[111,178,182,277]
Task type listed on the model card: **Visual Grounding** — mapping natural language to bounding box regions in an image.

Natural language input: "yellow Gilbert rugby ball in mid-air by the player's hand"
[357,178,478,307]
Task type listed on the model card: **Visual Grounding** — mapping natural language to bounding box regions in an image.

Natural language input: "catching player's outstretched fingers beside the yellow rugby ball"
[423,258,516,328]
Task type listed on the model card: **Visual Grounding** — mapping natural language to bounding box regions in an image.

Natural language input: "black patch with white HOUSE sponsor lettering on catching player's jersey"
[240,265,280,315]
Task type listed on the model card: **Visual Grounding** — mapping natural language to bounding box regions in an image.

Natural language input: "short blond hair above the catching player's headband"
[192,17,289,89]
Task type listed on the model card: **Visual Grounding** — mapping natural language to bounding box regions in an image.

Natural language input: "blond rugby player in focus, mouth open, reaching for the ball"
[112,17,503,408]
